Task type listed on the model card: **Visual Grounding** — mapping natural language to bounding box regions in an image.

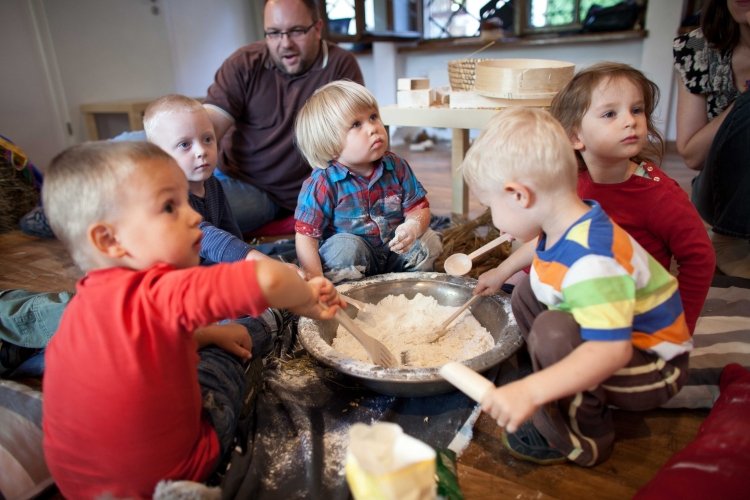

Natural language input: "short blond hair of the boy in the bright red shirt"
[42,141,174,271]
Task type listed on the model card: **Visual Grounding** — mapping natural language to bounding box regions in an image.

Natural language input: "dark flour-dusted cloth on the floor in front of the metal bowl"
[221,351,518,500]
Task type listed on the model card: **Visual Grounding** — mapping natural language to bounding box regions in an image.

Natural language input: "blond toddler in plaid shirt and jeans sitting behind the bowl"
[294,80,442,283]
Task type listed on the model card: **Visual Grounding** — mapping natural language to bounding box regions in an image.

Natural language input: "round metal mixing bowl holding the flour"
[299,272,523,397]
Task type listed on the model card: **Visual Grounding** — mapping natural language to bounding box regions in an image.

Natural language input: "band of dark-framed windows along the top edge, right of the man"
[323,0,646,41]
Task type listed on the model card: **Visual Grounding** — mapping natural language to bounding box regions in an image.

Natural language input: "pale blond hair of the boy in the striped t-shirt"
[461,107,577,192]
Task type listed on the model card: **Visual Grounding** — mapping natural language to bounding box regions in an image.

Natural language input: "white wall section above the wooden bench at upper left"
[43,0,175,145]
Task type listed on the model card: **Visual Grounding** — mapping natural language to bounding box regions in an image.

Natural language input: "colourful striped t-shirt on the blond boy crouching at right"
[531,200,693,360]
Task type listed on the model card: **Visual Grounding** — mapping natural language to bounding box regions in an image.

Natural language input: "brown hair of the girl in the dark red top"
[550,62,664,169]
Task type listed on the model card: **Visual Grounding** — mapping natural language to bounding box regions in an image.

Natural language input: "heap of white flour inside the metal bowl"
[332,294,495,367]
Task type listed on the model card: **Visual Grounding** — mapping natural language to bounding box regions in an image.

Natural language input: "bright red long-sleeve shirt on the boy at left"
[43,261,267,498]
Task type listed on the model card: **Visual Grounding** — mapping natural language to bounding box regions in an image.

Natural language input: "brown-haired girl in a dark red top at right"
[550,62,716,332]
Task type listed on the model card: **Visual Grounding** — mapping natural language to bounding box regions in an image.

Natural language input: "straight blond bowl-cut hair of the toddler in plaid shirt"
[294,80,380,168]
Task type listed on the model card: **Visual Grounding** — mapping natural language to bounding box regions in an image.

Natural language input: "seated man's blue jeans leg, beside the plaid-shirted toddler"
[214,169,282,233]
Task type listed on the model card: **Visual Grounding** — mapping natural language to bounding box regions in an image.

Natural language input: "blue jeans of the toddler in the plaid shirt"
[320,229,443,283]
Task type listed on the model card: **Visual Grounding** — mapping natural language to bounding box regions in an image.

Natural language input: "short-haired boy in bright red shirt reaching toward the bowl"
[42,142,340,498]
